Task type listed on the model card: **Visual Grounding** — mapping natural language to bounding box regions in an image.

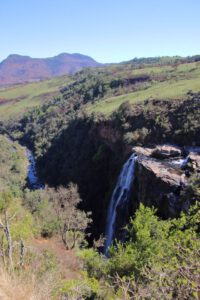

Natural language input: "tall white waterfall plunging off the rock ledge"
[104,154,137,255]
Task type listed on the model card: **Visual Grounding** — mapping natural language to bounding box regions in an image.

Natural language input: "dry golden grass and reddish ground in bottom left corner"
[0,239,81,300]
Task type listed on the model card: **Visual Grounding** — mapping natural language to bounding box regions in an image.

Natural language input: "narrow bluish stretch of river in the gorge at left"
[26,149,44,190]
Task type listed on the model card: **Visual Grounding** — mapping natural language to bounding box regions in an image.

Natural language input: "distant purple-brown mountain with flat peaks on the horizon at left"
[0,53,101,86]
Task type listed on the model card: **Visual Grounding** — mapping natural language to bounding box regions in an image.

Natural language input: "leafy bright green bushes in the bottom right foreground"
[69,204,200,300]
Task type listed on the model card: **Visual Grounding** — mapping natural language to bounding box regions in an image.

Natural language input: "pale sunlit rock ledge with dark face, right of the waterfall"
[133,145,200,217]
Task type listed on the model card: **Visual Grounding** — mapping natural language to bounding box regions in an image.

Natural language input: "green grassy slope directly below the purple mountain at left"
[0,76,70,120]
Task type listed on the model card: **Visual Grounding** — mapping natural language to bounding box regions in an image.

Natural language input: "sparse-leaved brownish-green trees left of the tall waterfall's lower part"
[24,183,92,250]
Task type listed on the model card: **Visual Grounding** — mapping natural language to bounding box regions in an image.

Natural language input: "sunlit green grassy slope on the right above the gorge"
[87,63,200,115]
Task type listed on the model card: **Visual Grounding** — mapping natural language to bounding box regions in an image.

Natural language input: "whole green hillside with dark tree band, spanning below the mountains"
[0,60,200,120]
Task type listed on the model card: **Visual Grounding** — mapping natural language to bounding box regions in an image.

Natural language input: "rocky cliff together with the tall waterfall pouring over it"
[103,145,200,244]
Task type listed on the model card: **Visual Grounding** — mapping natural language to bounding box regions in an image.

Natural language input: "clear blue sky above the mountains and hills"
[0,0,200,62]
